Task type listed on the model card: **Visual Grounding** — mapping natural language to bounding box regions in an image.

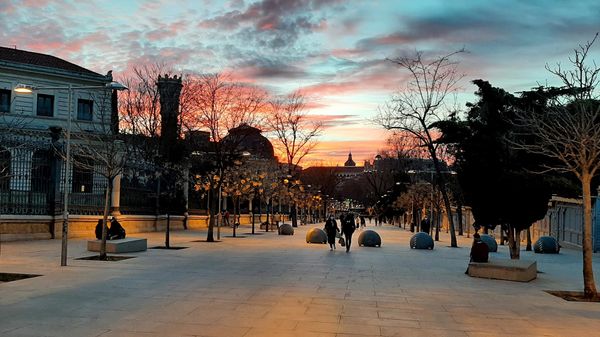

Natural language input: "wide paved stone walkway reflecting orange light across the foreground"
[0,222,600,337]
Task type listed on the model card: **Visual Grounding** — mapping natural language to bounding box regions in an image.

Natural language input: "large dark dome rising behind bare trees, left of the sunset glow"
[223,123,275,159]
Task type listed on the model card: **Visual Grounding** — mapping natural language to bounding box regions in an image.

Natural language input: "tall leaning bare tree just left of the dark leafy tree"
[377,49,464,247]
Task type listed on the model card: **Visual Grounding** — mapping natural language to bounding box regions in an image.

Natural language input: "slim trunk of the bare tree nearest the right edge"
[581,172,598,298]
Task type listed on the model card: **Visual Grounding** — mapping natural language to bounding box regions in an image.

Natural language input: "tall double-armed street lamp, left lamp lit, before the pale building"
[14,81,128,266]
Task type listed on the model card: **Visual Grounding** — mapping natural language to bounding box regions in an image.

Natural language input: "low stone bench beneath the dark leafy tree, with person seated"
[469,259,537,282]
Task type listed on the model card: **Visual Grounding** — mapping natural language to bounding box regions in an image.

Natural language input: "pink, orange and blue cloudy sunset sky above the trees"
[0,0,600,166]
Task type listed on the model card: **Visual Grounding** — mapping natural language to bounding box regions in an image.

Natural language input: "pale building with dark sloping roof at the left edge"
[0,47,114,240]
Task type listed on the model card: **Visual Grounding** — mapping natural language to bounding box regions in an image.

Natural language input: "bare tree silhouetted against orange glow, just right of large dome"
[267,92,323,227]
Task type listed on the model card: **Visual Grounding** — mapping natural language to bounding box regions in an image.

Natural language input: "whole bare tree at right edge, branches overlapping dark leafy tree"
[513,34,600,298]
